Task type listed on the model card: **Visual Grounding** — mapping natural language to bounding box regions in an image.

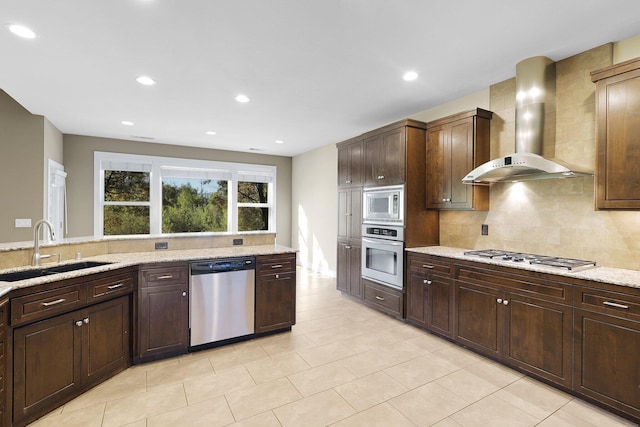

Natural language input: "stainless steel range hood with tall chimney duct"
[462,56,593,184]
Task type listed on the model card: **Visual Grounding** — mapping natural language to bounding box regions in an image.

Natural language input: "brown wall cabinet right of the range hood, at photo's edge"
[591,58,640,209]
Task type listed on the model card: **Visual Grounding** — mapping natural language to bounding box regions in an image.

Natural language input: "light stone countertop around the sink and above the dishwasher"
[0,245,297,297]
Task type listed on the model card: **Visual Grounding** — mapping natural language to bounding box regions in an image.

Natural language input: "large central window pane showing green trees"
[162,177,228,233]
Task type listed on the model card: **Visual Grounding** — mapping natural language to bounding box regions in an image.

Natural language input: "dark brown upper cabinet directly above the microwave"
[364,120,425,187]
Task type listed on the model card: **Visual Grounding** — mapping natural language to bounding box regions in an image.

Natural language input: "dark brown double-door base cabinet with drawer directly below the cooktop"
[454,265,573,387]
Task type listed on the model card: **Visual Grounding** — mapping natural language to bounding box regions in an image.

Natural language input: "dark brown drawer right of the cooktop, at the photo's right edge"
[575,288,640,319]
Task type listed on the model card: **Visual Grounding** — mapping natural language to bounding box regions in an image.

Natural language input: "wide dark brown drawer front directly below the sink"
[11,284,87,325]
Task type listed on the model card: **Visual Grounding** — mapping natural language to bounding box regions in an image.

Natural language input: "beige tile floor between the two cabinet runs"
[32,268,635,427]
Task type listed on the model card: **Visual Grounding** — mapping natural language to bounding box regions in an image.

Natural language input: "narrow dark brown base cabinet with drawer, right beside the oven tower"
[406,253,453,337]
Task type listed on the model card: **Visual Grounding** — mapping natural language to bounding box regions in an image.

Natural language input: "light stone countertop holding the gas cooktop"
[406,246,640,289]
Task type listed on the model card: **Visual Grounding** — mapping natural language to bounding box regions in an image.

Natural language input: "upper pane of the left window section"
[104,170,151,202]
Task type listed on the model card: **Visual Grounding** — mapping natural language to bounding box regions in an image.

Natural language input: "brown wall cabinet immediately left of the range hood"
[426,108,493,210]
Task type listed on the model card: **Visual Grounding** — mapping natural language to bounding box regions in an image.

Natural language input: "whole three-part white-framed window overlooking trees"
[94,152,276,237]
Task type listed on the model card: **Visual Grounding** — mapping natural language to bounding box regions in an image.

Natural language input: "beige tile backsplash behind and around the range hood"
[440,44,640,270]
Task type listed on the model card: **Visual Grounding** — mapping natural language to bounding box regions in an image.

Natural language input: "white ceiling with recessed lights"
[0,0,640,156]
